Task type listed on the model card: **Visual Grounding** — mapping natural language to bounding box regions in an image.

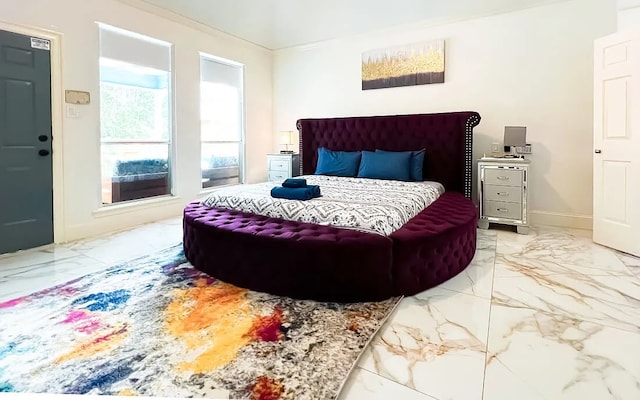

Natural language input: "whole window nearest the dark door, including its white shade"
[100,24,172,204]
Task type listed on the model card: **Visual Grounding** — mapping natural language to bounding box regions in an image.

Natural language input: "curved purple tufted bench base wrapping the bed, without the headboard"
[184,192,477,301]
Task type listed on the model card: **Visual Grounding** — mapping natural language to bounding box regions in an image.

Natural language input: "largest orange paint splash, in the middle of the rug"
[165,279,253,373]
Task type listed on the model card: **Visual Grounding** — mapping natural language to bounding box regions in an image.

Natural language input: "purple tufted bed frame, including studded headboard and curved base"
[183,112,480,302]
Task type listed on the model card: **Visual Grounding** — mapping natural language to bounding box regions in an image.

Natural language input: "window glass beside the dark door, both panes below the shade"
[100,57,171,204]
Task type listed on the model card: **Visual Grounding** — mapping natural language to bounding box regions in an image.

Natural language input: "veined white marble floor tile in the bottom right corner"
[484,305,640,400]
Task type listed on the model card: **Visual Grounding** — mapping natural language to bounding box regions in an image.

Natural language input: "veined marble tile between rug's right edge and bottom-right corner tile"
[359,288,490,400]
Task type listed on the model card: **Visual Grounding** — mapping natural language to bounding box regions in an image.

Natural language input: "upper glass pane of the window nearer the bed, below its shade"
[200,82,242,142]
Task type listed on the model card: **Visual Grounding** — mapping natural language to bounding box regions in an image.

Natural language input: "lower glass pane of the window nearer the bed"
[201,143,240,188]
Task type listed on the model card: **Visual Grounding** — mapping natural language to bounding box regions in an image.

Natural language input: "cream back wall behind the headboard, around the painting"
[274,0,616,229]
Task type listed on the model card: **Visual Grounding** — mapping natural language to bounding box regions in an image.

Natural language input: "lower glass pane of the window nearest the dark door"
[101,142,171,204]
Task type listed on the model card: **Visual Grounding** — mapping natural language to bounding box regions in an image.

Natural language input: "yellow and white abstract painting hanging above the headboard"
[362,39,444,90]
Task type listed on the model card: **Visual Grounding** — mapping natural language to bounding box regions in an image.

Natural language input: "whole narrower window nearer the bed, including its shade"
[200,55,244,188]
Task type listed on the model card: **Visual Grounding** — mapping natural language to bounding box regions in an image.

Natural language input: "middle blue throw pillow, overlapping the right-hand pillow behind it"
[358,151,411,181]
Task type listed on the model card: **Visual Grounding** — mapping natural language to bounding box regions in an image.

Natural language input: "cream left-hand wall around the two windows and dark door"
[0,0,273,242]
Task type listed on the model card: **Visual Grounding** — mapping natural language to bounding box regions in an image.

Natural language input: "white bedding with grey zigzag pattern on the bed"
[202,175,444,236]
